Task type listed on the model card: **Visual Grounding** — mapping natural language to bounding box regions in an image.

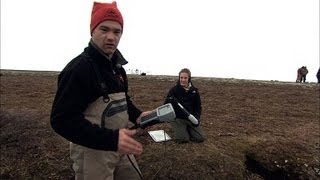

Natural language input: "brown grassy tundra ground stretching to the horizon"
[0,70,320,180]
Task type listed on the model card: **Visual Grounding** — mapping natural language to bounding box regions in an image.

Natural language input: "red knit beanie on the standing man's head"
[90,1,123,34]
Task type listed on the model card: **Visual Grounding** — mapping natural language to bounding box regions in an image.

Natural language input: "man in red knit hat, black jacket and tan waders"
[50,2,150,180]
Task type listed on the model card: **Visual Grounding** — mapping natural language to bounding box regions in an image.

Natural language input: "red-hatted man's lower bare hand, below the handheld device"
[118,129,142,155]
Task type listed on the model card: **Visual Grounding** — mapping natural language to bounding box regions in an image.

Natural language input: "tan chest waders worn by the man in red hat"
[70,58,141,180]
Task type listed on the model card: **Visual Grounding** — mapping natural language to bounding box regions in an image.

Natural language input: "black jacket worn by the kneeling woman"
[164,82,202,122]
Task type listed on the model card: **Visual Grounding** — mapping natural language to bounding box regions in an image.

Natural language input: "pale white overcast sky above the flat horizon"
[1,0,319,82]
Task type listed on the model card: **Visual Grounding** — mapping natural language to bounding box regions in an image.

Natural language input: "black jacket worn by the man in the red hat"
[50,43,141,151]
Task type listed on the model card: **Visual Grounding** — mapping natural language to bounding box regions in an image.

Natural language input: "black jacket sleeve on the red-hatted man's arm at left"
[50,63,119,151]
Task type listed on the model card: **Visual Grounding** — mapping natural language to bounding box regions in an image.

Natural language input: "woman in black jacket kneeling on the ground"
[164,68,205,143]
